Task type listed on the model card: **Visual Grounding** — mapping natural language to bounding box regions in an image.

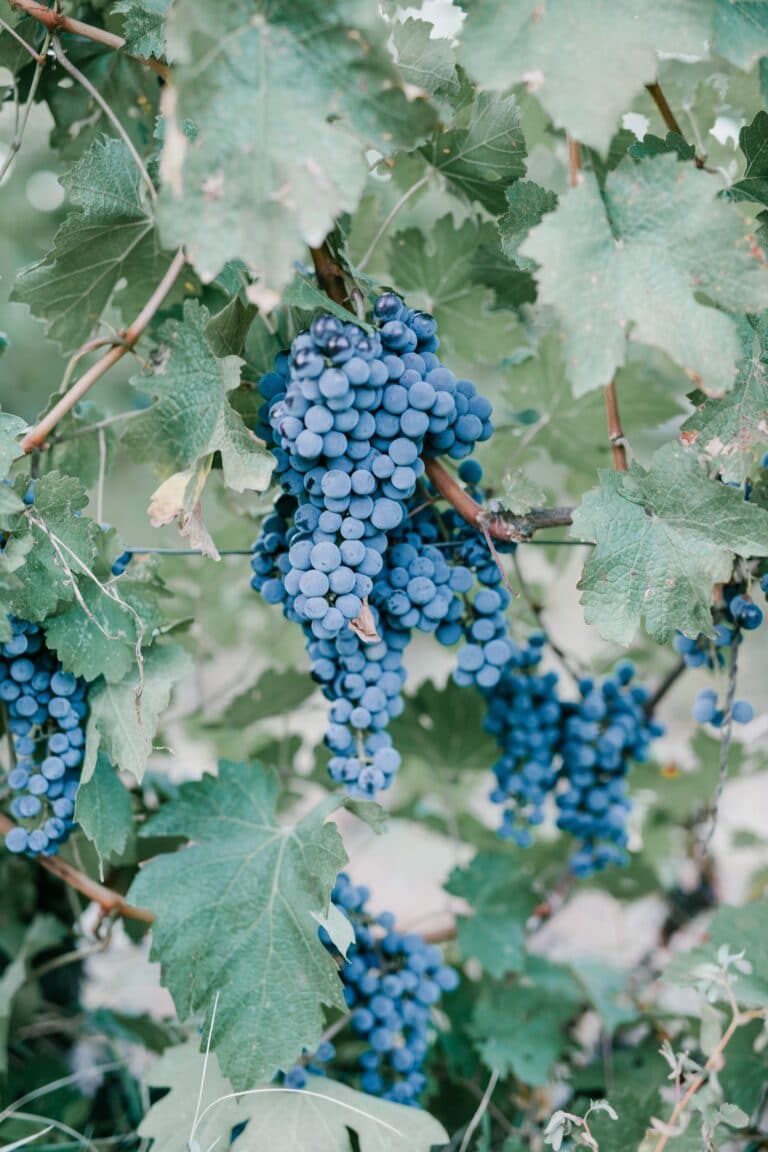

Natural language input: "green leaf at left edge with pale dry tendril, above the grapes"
[5,472,98,621]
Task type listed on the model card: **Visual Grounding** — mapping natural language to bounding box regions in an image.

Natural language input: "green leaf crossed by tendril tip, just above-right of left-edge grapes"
[45,569,166,683]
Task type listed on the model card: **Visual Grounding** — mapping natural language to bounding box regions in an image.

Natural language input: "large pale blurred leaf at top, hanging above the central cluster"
[161,0,435,306]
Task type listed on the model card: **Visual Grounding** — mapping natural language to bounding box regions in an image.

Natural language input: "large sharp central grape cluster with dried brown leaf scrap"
[251,293,492,796]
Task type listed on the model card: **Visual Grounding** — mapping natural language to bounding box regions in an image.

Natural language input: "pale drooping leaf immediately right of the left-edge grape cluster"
[83,644,191,782]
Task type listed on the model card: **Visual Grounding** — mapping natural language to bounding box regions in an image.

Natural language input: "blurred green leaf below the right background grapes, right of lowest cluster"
[446,852,537,979]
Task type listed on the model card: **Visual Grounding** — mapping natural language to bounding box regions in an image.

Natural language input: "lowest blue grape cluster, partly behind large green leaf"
[284,872,458,1105]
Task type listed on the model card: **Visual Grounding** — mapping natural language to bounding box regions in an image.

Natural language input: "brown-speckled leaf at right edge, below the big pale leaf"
[682,311,768,484]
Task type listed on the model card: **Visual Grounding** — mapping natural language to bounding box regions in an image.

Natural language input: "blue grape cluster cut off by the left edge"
[0,619,88,856]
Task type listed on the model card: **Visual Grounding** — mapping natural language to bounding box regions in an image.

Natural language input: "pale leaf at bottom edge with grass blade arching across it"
[139,1041,448,1152]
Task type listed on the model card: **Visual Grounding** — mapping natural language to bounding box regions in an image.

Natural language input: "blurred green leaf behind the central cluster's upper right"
[389,217,518,364]
